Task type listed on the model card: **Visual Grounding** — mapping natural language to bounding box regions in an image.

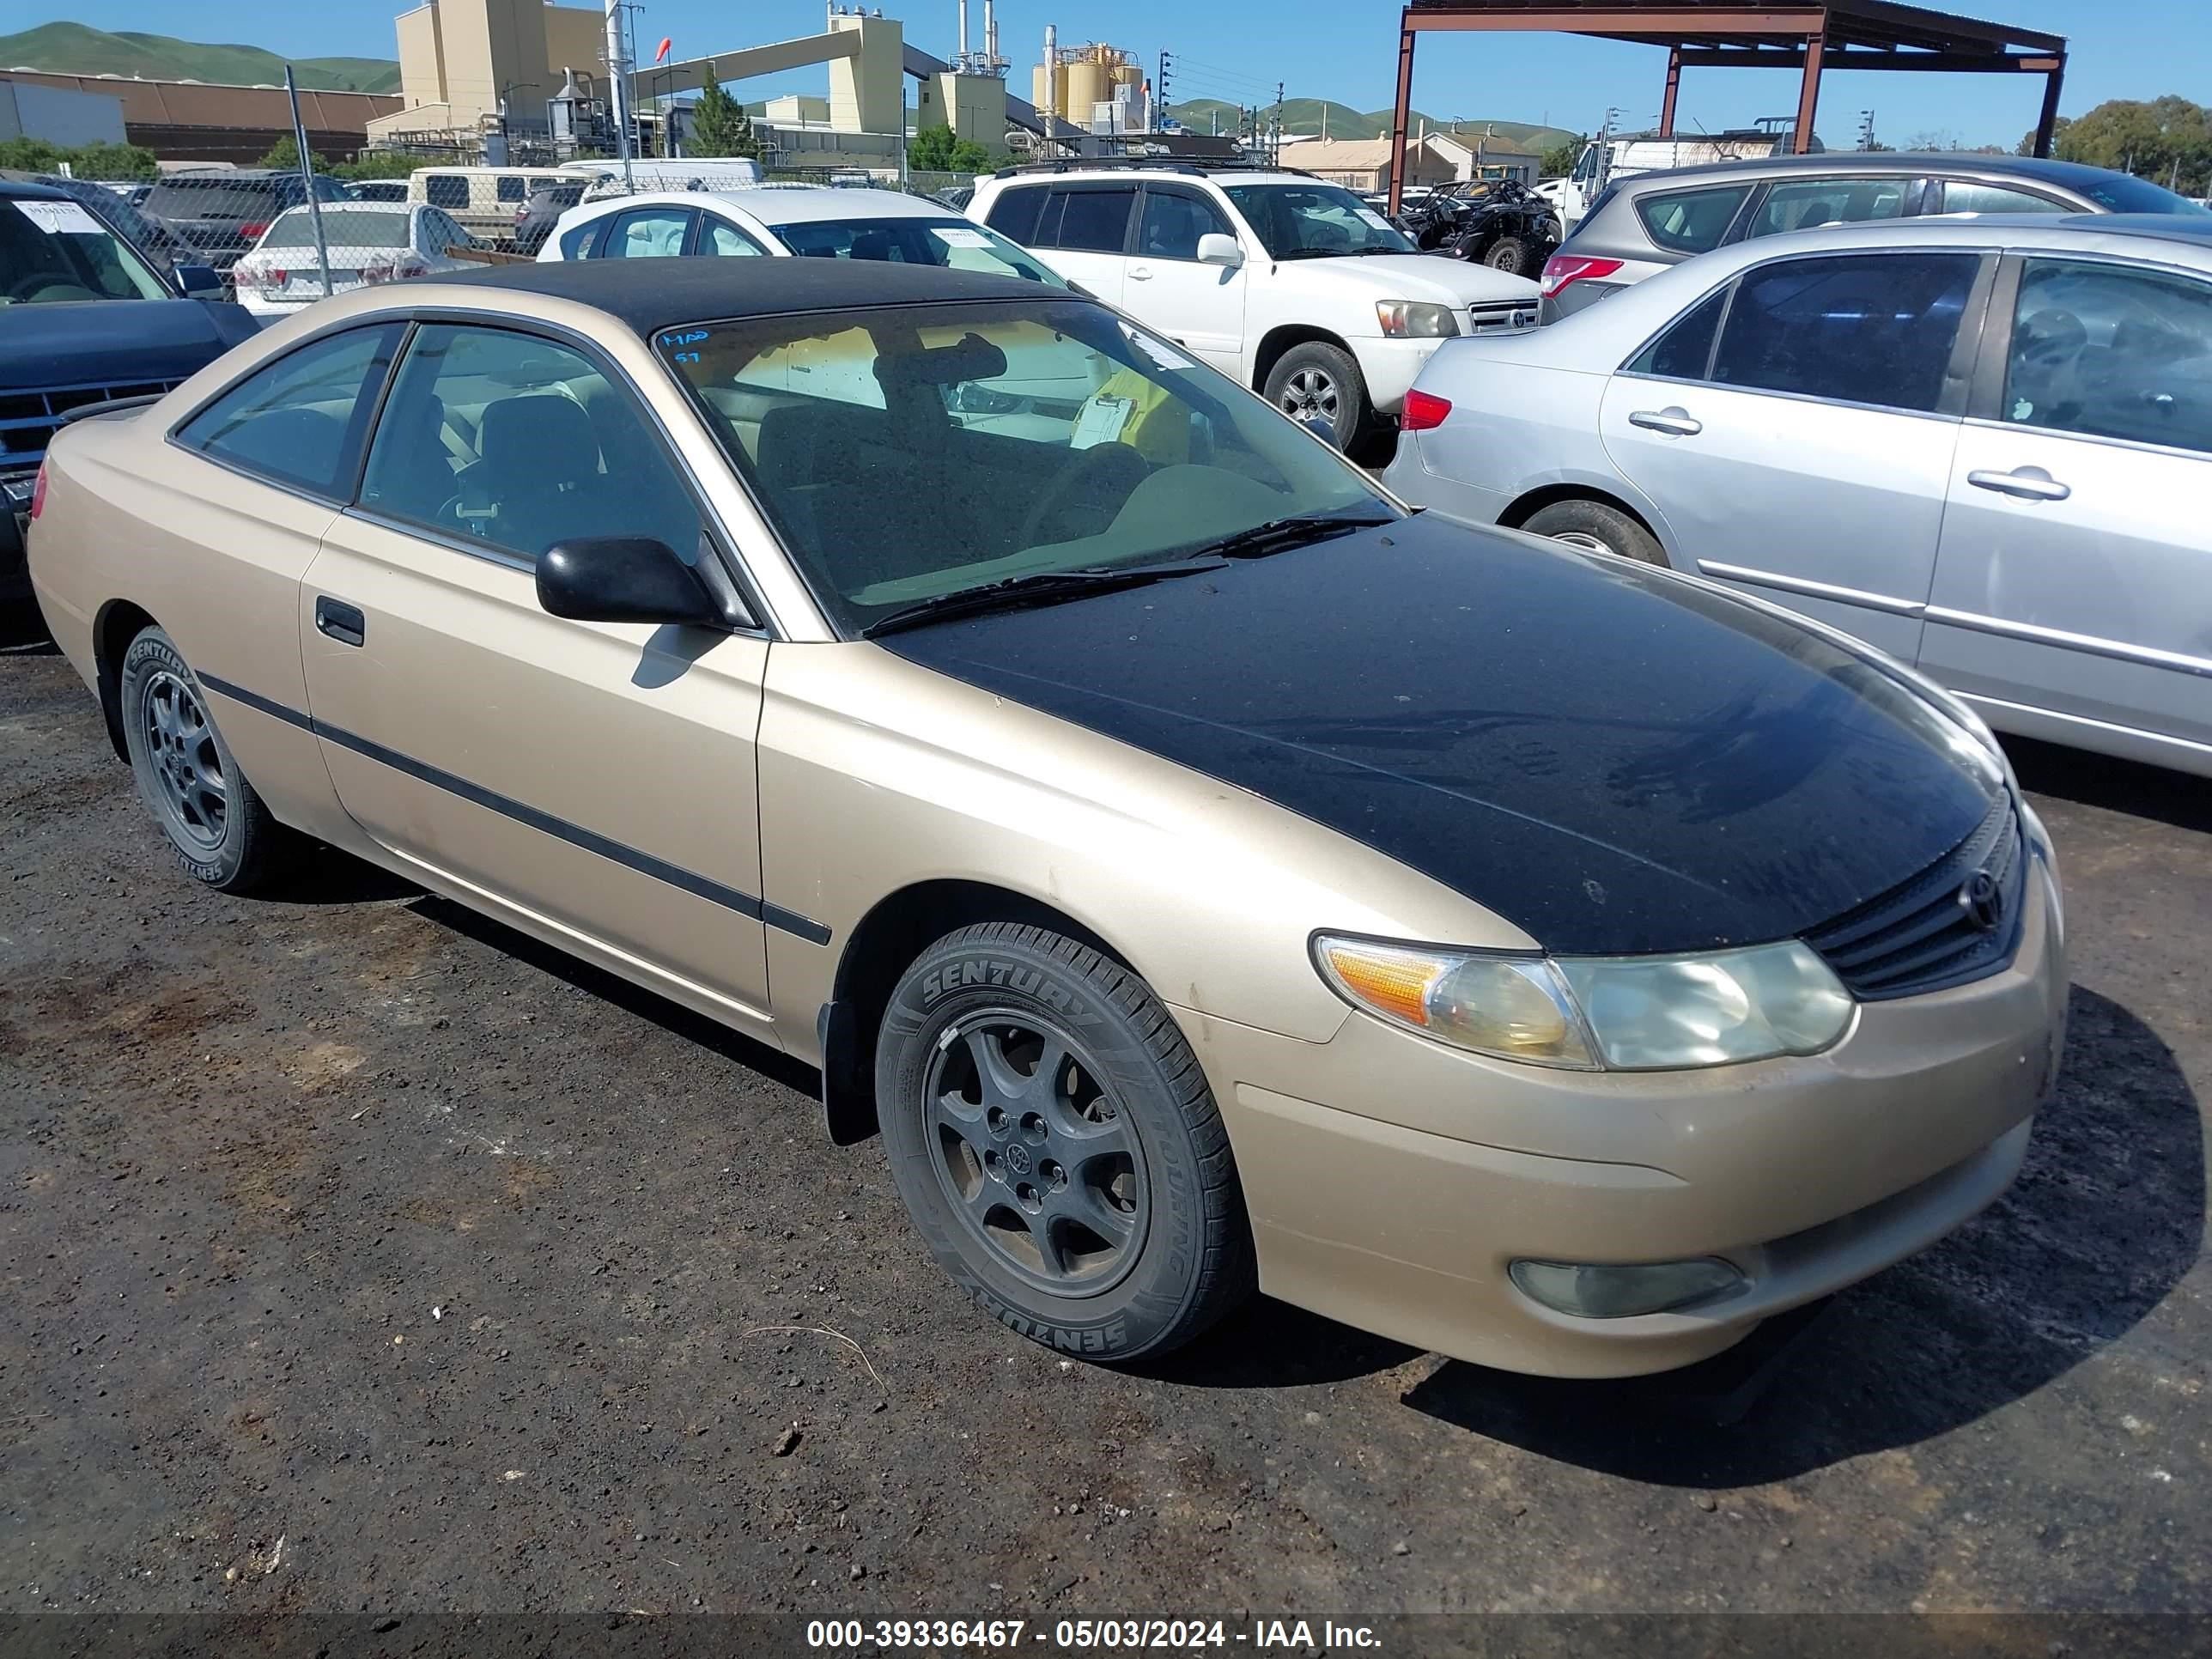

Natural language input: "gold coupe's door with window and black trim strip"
[299,323,768,1022]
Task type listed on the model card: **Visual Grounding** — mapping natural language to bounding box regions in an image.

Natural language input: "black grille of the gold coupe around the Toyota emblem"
[1805,794,2027,1002]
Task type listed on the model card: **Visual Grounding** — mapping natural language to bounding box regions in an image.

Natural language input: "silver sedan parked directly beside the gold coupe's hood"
[1389,215,2212,775]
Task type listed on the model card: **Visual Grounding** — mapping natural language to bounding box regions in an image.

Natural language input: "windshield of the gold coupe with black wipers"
[654,299,1398,633]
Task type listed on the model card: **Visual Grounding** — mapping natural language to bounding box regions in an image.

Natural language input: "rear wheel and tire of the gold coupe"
[122,629,305,894]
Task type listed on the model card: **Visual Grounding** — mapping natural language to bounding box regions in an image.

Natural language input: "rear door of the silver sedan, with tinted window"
[1599,250,1990,661]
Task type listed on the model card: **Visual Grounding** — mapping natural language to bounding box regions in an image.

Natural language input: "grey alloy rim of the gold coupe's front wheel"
[922,1009,1151,1297]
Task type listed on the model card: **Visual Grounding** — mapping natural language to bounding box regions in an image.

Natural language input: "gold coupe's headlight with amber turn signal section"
[1314,933,1854,1071]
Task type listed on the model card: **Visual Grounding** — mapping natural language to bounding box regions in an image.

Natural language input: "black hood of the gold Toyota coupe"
[883,518,2002,953]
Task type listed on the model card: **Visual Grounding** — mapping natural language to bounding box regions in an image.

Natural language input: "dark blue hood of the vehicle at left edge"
[0,299,257,392]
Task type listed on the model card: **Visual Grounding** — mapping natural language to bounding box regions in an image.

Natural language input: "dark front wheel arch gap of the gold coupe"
[814,878,1141,1146]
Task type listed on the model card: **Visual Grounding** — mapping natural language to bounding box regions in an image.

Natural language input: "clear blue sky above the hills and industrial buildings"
[43,0,2212,146]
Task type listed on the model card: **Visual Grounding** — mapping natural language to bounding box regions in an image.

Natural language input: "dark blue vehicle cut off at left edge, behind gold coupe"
[0,179,254,602]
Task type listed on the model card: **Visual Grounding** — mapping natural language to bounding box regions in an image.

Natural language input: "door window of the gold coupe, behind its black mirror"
[361,323,699,560]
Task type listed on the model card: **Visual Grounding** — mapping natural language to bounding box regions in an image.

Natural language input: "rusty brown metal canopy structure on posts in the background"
[1389,0,2066,212]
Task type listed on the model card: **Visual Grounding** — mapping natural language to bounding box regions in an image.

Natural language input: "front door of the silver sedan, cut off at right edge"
[1920,254,2212,763]
